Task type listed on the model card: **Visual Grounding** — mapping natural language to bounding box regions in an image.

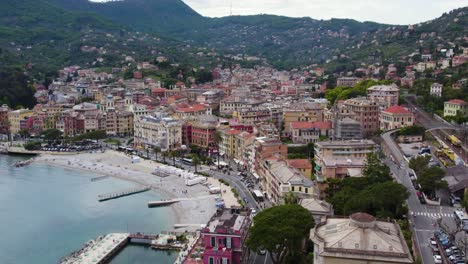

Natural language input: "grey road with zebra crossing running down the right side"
[382,132,454,264]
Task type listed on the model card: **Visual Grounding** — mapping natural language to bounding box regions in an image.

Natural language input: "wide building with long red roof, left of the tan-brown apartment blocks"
[289,121,332,144]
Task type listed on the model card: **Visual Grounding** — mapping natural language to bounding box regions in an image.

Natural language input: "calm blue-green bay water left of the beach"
[0,155,177,264]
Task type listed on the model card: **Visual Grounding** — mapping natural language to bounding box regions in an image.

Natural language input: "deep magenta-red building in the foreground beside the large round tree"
[201,208,251,264]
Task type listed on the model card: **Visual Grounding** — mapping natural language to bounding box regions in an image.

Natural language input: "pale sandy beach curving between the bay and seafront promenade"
[35,150,237,230]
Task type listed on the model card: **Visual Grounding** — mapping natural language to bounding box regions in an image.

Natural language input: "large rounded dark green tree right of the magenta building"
[246,204,315,264]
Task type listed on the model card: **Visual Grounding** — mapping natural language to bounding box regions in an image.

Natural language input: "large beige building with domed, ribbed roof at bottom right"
[310,213,413,264]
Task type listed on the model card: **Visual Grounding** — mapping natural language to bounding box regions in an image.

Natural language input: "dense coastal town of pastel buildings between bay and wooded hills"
[0,40,468,263]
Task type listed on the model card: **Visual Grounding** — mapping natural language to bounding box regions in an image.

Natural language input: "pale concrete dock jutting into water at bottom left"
[59,233,130,264]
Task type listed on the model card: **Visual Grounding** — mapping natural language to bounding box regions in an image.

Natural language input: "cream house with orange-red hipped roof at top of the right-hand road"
[380,105,414,130]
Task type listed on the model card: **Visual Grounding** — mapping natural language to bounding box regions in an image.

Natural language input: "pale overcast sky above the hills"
[183,0,468,24]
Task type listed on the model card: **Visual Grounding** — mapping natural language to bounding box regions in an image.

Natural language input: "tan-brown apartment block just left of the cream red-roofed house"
[340,97,380,137]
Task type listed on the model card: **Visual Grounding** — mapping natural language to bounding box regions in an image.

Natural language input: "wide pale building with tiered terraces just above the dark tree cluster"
[314,140,375,182]
